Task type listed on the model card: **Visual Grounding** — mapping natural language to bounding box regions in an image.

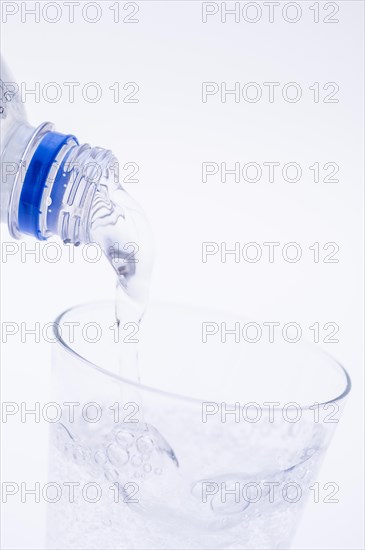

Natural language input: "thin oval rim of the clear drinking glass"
[52,300,352,412]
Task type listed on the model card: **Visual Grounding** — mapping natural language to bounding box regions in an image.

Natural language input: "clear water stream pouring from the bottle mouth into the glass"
[86,159,153,388]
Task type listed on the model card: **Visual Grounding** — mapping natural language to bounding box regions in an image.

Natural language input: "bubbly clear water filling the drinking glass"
[48,402,322,550]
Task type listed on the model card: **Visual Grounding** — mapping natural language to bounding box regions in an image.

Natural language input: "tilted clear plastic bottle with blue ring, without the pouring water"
[0,59,116,244]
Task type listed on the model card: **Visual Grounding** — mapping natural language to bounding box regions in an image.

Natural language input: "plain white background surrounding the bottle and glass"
[1,1,364,549]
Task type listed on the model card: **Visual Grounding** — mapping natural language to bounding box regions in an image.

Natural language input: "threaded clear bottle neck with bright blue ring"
[9,131,116,245]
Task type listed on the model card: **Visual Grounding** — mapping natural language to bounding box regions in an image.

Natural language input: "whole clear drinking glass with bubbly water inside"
[47,302,350,550]
